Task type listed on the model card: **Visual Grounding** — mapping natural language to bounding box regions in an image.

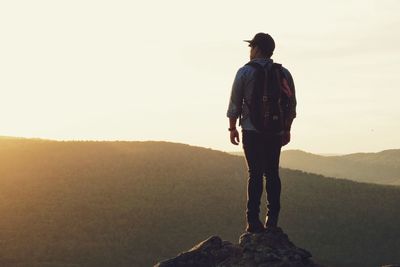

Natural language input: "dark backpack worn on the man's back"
[246,62,288,134]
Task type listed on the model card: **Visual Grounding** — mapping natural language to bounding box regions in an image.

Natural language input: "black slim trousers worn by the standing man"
[242,130,282,221]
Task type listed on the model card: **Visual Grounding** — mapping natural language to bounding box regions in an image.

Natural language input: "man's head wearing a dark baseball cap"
[245,32,275,59]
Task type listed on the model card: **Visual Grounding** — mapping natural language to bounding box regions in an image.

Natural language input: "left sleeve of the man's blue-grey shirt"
[226,68,244,119]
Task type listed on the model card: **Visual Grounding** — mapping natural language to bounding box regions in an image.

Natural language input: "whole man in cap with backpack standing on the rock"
[227,33,296,232]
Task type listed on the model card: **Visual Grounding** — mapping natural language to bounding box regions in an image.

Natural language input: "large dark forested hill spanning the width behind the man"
[0,139,400,267]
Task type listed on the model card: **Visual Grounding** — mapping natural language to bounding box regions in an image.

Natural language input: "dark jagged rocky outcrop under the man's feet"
[155,227,322,267]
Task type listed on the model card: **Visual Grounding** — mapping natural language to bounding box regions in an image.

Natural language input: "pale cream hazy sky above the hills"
[0,0,400,154]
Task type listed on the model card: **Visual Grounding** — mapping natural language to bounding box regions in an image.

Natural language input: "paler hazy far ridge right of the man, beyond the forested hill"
[281,149,400,185]
